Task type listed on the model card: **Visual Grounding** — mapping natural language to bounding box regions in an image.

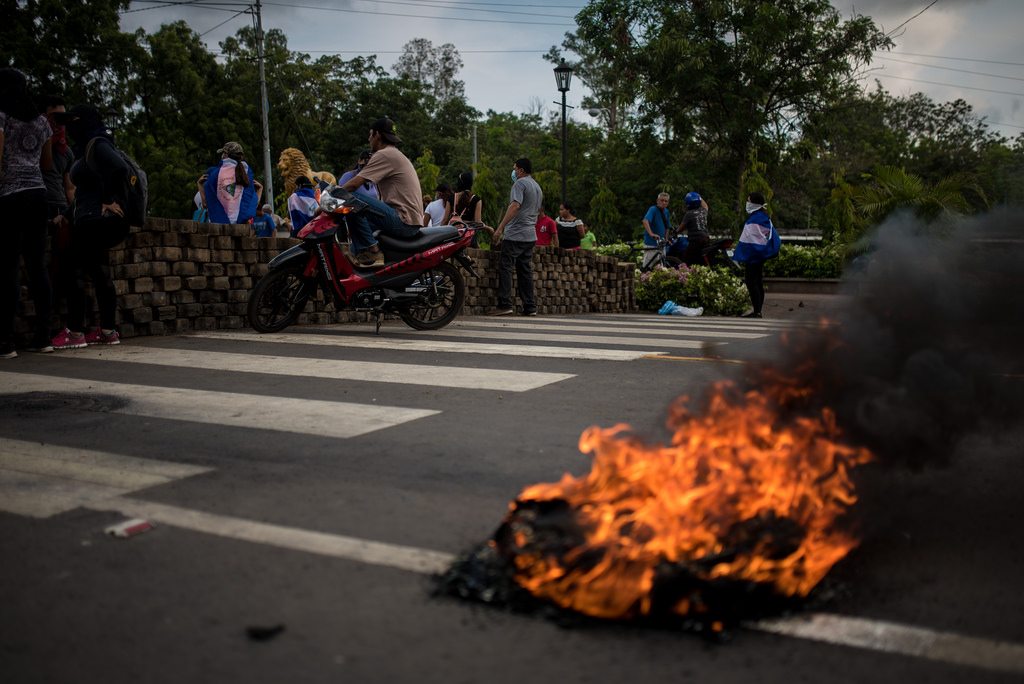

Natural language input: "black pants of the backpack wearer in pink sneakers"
[56,216,128,333]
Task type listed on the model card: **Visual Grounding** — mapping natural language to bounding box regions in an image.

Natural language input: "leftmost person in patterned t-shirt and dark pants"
[0,69,53,358]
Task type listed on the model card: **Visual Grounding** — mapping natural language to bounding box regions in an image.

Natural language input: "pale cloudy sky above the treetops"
[121,0,1024,138]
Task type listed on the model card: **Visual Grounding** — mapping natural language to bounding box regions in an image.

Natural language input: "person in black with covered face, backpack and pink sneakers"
[52,104,131,349]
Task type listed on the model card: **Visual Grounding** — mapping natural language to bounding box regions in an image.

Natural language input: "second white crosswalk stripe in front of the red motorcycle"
[67,345,575,392]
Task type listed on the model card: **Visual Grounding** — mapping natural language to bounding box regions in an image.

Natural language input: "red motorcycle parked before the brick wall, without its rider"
[249,182,480,333]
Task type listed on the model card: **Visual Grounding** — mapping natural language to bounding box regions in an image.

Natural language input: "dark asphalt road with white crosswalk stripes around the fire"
[0,305,1024,683]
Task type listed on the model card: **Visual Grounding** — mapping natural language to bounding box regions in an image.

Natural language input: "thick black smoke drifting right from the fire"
[744,206,1024,465]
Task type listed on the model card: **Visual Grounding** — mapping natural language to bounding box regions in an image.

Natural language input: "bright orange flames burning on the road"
[510,374,871,618]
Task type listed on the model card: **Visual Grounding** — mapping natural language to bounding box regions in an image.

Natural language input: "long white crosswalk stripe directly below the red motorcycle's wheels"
[188,328,671,361]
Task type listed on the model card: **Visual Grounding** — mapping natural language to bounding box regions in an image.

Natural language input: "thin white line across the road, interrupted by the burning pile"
[91,497,1024,674]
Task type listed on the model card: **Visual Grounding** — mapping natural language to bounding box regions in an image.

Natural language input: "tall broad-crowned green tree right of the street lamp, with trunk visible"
[577,0,892,209]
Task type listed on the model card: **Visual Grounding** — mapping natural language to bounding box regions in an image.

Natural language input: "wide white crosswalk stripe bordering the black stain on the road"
[0,373,440,438]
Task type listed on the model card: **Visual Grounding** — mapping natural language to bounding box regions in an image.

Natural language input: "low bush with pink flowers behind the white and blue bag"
[636,265,749,315]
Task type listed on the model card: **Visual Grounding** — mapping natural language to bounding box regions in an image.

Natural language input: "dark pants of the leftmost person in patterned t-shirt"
[0,189,52,344]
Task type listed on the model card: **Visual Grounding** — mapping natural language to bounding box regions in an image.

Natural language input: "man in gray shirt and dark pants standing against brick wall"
[487,157,544,315]
